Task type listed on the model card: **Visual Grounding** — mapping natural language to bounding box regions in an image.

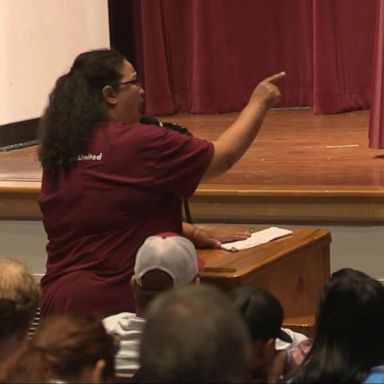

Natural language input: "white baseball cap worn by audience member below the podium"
[134,232,203,287]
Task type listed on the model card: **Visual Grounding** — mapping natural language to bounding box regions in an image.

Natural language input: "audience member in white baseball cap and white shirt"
[103,233,199,377]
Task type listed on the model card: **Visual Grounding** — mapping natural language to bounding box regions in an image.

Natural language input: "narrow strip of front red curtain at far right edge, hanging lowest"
[369,0,384,148]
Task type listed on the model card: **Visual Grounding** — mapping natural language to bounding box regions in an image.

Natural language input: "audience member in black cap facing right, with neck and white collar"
[231,286,307,383]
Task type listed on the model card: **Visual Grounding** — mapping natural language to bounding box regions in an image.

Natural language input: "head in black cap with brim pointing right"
[230,286,292,376]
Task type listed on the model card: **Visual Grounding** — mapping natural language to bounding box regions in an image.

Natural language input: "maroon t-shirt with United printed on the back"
[39,122,213,317]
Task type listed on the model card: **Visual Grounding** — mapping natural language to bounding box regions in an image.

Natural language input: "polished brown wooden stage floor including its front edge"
[0,109,384,224]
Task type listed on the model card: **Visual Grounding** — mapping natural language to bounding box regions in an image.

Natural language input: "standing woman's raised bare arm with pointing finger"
[202,72,285,181]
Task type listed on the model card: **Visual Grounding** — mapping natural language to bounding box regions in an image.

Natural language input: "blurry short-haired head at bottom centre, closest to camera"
[140,284,250,383]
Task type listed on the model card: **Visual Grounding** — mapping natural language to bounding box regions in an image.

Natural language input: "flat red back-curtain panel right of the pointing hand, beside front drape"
[313,0,377,113]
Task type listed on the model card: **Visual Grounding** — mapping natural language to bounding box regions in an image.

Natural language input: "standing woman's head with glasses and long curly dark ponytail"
[39,49,144,172]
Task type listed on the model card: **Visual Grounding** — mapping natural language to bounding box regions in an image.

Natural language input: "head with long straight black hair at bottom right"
[293,268,384,383]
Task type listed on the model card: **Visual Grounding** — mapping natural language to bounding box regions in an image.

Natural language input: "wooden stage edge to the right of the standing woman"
[191,188,384,224]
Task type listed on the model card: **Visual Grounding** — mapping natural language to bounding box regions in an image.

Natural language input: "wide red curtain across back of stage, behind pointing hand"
[132,0,377,115]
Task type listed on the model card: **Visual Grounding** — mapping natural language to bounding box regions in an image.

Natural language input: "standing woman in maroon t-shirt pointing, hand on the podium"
[38,49,285,317]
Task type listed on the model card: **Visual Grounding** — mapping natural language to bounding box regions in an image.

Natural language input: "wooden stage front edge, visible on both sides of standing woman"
[0,177,384,224]
